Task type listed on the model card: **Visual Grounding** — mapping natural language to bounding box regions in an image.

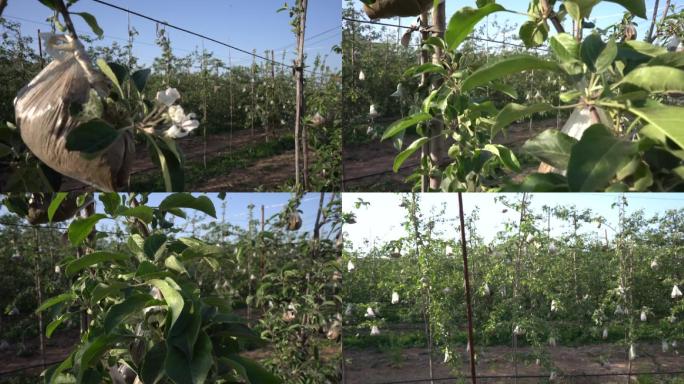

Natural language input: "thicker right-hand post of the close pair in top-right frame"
[428,0,446,190]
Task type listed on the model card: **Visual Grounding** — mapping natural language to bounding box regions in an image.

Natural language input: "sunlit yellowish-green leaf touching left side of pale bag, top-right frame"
[522,129,577,170]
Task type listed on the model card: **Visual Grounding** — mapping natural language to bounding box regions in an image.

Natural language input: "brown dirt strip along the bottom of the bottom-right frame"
[345,344,684,384]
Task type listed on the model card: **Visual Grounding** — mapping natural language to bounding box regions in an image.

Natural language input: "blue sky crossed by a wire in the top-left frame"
[3,0,341,68]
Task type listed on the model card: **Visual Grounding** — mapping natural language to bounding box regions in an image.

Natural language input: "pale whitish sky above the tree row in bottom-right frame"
[342,193,684,252]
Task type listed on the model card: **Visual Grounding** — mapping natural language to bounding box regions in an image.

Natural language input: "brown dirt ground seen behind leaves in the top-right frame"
[343,118,557,191]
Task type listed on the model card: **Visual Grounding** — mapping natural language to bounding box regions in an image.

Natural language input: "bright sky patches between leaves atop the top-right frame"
[354,0,684,46]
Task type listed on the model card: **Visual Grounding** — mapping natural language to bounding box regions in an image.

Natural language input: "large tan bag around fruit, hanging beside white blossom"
[14,34,134,191]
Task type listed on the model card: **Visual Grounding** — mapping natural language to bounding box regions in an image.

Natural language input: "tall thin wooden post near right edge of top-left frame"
[294,0,308,189]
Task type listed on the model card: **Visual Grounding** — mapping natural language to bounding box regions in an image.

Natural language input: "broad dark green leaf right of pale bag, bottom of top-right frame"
[568,124,638,192]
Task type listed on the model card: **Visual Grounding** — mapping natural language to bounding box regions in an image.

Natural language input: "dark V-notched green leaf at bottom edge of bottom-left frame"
[164,331,214,384]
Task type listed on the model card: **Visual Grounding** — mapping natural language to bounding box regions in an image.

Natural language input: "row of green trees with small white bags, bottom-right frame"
[342,195,684,372]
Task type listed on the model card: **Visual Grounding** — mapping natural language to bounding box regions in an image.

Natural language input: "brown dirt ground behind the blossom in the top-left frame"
[62,129,294,192]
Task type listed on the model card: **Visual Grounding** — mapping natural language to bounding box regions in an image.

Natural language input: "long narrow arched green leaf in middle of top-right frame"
[461,55,560,92]
